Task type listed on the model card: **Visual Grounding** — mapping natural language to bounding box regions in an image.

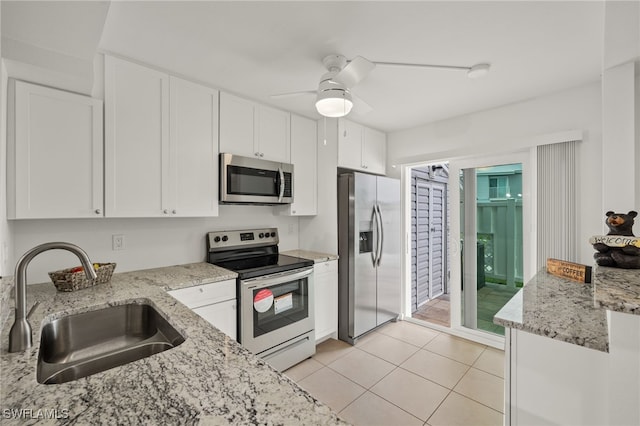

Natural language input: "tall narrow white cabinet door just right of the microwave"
[288,115,318,216]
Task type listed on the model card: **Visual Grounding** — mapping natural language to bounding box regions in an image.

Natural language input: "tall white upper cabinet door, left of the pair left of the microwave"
[105,56,169,217]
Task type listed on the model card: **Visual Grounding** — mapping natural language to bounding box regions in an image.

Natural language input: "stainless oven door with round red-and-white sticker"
[239,267,314,354]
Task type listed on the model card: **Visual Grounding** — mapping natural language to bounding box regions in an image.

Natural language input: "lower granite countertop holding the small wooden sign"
[493,269,609,352]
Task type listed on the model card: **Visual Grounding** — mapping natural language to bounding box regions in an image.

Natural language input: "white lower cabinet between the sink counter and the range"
[169,280,237,340]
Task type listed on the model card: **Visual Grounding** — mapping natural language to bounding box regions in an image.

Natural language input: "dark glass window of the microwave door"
[227,166,280,197]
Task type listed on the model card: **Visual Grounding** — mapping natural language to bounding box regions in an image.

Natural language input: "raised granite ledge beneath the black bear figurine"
[593,266,640,315]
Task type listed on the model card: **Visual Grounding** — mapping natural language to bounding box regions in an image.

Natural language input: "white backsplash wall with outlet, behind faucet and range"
[10,205,298,284]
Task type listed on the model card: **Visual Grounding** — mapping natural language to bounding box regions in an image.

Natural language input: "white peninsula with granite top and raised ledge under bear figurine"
[494,266,640,425]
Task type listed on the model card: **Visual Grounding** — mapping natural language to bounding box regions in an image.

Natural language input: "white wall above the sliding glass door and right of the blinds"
[387,81,604,264]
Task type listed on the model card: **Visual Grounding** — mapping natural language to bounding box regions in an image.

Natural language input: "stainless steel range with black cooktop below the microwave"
[207,228,315,371]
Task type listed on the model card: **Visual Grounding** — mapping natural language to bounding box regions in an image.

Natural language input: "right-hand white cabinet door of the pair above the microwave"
[256,105,291,163]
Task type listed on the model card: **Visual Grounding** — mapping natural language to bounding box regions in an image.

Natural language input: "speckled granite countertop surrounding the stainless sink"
[0,263,343,425]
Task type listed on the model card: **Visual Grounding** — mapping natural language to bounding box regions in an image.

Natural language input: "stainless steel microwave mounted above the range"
[220,153,293,204]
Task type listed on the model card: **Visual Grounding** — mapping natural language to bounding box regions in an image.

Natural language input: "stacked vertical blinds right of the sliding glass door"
[537,141,578,270]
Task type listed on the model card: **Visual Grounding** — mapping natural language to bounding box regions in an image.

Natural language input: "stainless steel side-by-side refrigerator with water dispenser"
[338,172,401,344]
